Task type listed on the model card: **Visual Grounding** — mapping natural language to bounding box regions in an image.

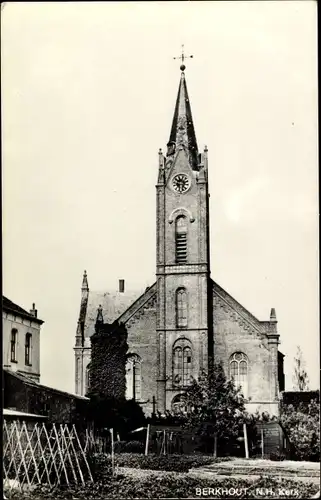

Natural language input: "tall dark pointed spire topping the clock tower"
[167,65,198,170]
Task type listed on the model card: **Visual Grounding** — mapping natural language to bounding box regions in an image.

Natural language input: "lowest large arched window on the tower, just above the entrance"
[173,339,193,387]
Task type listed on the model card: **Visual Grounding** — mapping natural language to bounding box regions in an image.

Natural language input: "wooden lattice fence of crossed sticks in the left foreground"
[2,421,93,490]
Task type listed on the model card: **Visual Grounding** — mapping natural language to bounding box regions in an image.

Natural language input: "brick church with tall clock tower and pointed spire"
[74,60,284,415]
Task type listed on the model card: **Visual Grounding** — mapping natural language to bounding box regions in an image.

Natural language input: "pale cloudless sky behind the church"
[1,1,319,392]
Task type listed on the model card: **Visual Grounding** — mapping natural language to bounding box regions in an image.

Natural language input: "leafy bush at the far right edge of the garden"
[280,400,320,461]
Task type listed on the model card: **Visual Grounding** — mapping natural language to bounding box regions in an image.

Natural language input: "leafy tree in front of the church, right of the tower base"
[181,364,247,451]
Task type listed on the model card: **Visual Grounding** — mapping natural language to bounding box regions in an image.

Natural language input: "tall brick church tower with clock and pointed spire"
[156,64,213,412]
